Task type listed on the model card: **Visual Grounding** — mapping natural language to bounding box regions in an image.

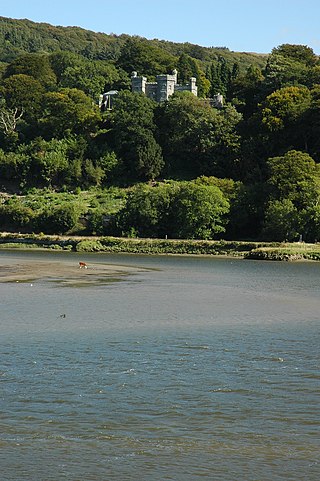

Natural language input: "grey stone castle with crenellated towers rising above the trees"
[131,70,198,102]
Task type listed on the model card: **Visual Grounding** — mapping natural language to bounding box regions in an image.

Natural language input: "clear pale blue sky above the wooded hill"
[0,0,320,55]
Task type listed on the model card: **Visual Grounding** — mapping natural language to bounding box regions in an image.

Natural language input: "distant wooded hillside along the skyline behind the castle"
[0,17,266,69]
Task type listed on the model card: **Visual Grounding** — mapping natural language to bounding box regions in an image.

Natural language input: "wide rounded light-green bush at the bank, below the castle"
[114,182,229,239]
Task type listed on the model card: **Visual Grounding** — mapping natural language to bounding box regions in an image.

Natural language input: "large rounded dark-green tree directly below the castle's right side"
[157,93,241,176]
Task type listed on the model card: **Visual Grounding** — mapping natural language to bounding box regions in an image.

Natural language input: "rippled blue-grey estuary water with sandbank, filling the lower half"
[0,251,320,481]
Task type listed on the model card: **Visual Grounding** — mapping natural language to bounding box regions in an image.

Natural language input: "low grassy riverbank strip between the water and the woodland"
[0,232,320,261]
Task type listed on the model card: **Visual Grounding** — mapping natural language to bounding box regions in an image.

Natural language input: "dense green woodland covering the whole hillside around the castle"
[0,17,320,242]
